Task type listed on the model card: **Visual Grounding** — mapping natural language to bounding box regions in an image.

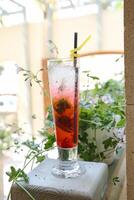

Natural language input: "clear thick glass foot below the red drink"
[52,147,85,178]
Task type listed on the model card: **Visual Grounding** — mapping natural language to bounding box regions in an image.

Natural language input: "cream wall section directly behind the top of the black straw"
[53,15,97,57]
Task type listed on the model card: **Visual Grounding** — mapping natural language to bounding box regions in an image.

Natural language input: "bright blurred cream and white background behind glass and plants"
[0,0,124,200]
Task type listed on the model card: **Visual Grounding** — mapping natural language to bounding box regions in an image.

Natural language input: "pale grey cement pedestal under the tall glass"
[11,159,108,200]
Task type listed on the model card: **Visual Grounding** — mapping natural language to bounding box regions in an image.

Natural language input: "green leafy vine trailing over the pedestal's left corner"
[6,135,55,200]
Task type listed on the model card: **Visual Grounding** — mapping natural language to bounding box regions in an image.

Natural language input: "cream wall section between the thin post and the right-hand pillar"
[102,10,124,50]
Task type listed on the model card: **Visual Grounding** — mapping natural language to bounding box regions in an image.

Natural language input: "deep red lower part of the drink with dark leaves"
[53,97,78,148]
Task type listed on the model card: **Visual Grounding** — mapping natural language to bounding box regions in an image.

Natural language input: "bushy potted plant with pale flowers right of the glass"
[79,79,125,164]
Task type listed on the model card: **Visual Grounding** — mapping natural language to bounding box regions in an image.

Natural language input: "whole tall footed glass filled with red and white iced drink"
[48,59,82,178]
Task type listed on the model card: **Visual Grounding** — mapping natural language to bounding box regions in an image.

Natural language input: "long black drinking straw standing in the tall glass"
[74,32,78,143]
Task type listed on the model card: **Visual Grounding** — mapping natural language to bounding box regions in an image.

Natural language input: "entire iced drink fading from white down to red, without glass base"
[49,60,79,148]
